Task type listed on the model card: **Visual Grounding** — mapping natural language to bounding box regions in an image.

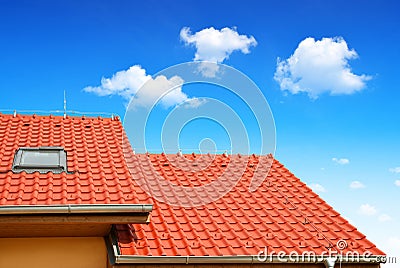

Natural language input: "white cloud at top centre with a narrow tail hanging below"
[180,27,257,77]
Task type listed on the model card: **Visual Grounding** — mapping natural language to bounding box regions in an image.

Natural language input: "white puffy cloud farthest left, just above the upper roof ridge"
[83,65,190,107]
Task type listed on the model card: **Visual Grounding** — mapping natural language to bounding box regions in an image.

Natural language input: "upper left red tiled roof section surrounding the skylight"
[0,114,149,205]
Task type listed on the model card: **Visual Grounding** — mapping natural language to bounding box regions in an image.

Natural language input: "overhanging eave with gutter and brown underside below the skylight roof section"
[0,204,153,237]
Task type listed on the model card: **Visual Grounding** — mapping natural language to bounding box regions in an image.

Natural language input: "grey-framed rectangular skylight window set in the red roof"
[12,147,67,173]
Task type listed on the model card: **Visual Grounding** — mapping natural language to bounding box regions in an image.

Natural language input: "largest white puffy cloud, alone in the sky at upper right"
[274,37,371,98]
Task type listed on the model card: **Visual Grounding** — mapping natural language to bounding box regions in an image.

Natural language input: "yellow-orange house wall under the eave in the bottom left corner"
[0,237,108,268]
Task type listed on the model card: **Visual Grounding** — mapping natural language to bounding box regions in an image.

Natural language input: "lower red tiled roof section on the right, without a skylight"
[116,154,384,256]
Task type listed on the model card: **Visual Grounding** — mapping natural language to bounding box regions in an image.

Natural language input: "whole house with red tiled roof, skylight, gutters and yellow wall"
[0,114,385,268]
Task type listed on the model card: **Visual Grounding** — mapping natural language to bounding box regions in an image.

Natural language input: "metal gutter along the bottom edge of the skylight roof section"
[0,204,153,215]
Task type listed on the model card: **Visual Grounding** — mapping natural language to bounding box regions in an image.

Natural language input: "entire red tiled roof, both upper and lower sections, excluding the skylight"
[0,114,383,256]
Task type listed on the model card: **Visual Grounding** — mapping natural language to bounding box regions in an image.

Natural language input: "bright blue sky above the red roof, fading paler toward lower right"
[0,0,400,261]
